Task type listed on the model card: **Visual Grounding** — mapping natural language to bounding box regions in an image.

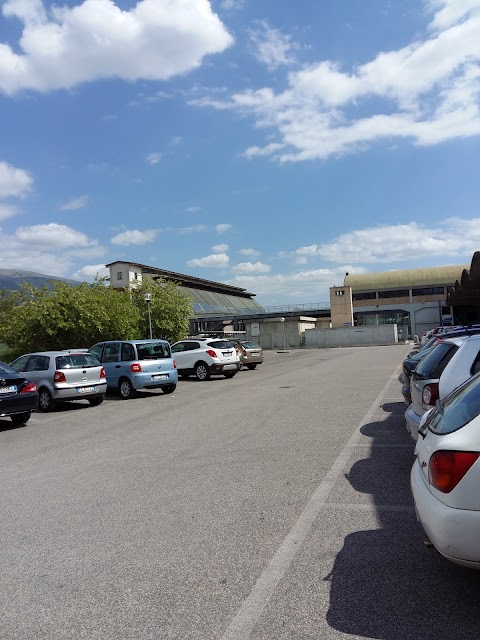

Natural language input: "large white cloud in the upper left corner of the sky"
[0,0,233,95]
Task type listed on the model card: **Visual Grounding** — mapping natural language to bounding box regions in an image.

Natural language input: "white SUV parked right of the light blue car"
[172,338,240,380]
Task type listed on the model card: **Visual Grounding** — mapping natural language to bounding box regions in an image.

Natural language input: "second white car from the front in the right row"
[405,334,480,440]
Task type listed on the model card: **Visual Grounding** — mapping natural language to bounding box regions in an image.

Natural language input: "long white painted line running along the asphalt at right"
[221,367,398,640]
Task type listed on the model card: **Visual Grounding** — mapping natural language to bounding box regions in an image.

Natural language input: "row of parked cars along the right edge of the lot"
[402,326,480,569]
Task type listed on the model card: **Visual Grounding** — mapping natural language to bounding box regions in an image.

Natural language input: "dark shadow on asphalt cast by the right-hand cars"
[324,403,480,640]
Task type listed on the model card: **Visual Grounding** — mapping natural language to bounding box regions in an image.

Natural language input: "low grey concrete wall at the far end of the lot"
[305,324,398,349]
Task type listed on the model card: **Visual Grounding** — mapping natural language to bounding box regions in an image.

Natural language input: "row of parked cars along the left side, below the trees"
[0,338,263,424]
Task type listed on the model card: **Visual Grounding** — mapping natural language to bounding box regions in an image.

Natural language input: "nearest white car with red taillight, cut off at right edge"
[410,374,480,569]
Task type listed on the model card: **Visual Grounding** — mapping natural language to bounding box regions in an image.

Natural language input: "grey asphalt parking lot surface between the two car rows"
[0,345,480,640]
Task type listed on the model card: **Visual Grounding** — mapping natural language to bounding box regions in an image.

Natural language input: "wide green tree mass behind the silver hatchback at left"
[2,280,141,356]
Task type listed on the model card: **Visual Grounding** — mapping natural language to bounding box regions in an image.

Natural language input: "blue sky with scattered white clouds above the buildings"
[0,0,480,305]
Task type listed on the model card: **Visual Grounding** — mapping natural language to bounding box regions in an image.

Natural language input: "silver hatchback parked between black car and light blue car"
[10,351,107,411]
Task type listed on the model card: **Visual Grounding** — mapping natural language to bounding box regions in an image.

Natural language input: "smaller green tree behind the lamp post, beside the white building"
[132,276,193,343]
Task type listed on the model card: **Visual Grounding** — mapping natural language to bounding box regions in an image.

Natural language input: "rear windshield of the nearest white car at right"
[428,375,480,434]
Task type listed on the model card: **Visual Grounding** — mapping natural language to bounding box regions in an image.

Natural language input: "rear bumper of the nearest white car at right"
[410,460,480,569]
